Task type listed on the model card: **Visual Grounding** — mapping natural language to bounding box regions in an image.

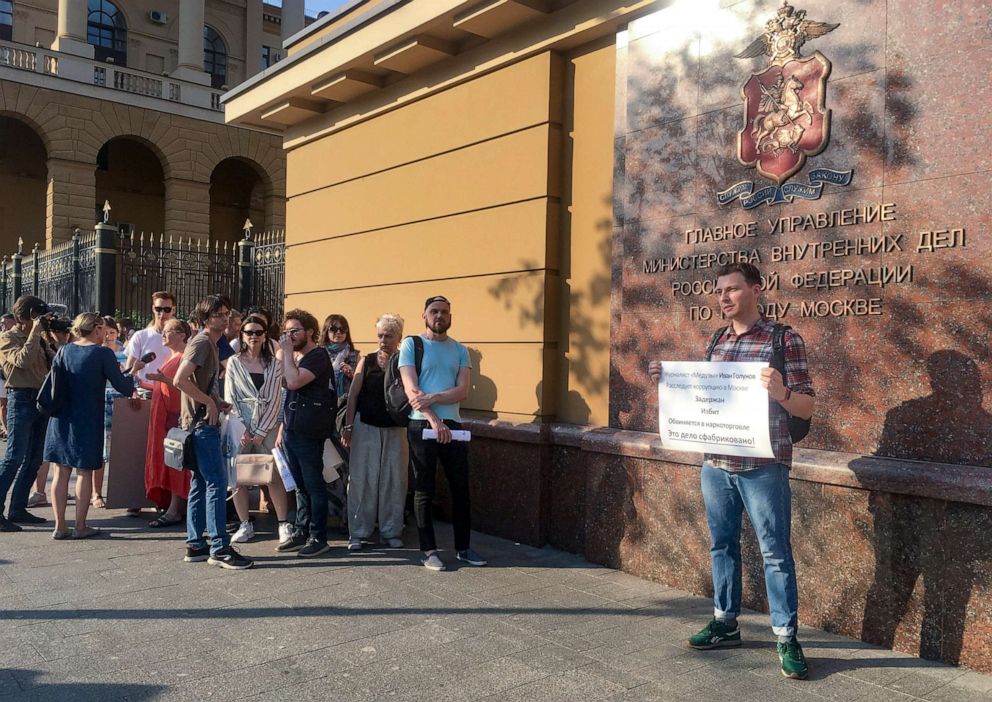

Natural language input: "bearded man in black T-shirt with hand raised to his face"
[276,310,337,558]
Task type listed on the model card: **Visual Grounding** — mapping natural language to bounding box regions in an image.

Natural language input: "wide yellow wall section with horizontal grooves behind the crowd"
[286,53,564,421]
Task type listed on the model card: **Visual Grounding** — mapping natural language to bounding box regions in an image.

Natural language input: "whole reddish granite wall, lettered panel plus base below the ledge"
[596,0,992,670]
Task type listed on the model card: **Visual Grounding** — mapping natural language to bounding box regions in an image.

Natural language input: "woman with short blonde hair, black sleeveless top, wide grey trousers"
[341,314,408,551]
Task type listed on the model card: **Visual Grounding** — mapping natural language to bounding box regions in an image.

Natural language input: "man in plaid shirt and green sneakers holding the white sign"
[648,263,814,679]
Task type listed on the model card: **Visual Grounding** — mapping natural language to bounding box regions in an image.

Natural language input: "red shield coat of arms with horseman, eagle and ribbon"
[718,2,851,209]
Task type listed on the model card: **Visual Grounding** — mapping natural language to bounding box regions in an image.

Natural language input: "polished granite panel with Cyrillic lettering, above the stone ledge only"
[610,0,992,454]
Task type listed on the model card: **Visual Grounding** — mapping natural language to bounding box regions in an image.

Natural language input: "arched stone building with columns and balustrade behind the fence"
[0,0,312,254]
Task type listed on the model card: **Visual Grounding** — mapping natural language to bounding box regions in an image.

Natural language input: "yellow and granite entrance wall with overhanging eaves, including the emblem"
[225,0,992,671]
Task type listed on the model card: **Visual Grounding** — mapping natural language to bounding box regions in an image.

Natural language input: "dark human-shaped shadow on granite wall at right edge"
[851,350,992,663]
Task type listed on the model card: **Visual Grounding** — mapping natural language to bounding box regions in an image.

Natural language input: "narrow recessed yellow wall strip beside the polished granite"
[558,36,616,426]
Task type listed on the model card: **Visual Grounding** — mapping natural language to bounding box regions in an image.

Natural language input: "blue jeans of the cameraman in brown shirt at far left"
[0,388,48,514]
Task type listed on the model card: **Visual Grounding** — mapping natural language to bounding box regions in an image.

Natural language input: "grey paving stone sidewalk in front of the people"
[0,506,992,702]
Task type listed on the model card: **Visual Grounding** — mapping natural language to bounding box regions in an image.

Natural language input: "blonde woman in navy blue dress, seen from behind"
[45,312,134,539]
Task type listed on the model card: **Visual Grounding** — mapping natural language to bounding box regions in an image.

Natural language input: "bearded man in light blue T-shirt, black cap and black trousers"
[399,295,486,571]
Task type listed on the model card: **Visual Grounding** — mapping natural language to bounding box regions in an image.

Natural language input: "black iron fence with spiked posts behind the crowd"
[0,224,286,325]
